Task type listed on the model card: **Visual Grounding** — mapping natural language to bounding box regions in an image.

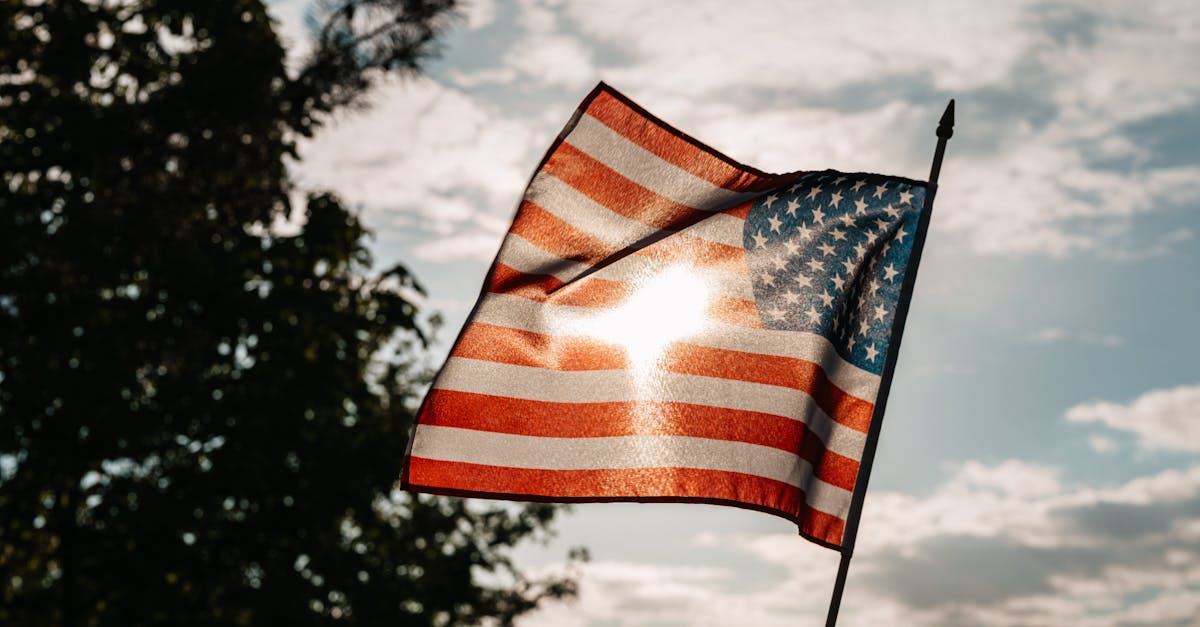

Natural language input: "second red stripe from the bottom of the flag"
[420,389,858,490]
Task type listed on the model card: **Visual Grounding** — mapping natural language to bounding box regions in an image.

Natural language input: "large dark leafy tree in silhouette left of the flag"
[0,0,574,627]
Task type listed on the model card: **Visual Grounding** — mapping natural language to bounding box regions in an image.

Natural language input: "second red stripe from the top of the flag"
[535,142,708,228]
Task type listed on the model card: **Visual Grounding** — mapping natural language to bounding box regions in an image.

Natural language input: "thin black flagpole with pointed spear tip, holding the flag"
[826,98,954,627]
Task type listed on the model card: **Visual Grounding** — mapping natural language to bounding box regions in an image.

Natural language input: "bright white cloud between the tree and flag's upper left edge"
[295,79,548,249]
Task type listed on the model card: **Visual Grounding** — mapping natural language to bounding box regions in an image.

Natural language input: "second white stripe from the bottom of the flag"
[433,357,866,460]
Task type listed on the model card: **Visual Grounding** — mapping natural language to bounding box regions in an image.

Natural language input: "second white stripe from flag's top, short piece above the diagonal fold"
[526,172,659,251]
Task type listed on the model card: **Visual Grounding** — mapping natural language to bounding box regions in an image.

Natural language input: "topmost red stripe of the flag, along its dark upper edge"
[586,92,786,191]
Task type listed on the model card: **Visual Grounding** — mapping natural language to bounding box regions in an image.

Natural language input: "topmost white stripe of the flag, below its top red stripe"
[566,115,760,211]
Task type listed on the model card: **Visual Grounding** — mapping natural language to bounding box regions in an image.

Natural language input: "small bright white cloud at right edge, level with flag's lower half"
[1067,386,1200,453]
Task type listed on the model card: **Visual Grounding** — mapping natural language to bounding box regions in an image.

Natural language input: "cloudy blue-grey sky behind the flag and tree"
[272,0,1200,627]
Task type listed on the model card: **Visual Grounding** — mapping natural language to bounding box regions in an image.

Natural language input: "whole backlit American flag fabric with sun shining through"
[402,83,926,548]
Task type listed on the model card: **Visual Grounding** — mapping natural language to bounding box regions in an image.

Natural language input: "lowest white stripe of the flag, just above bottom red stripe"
[413,425,851,518]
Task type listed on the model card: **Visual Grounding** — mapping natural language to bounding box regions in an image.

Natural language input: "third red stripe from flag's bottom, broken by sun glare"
[452,322,875,432]
